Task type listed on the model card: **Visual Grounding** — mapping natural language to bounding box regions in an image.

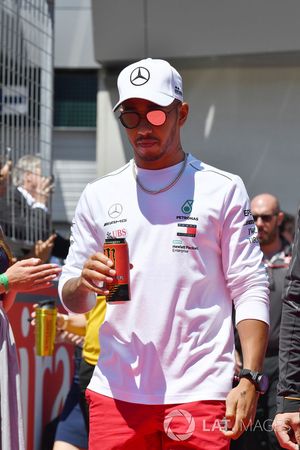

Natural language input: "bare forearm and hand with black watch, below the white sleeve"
[225,319,269,439]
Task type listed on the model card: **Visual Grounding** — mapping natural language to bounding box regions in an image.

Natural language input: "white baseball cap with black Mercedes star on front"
[113,58,183,111]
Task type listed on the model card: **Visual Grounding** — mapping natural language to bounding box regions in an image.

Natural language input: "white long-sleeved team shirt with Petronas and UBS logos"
[59,155,269,404]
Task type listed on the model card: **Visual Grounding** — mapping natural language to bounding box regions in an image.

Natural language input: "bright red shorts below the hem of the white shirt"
[86,389,230,450]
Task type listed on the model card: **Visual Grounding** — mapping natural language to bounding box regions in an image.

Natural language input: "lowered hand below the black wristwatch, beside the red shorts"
[223,378,259,439]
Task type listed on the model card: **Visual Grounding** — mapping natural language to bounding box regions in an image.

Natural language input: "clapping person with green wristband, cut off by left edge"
[0,226,61,450]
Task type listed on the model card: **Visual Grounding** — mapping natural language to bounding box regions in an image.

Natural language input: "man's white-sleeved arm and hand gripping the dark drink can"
[58,185,115,313]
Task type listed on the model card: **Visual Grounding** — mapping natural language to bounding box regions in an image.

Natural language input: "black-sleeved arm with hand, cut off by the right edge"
[273,209,300,450]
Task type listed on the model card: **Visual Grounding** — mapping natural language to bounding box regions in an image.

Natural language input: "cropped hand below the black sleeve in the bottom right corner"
[272,412,300,450]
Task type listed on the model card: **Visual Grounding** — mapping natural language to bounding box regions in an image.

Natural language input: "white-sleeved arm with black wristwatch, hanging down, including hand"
[221,177,269,439]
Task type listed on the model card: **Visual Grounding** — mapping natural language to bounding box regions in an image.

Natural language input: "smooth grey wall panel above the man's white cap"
[92,0,300,65]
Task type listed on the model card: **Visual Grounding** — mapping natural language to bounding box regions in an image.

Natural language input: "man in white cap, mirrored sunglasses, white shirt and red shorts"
[59,58,269,450]
